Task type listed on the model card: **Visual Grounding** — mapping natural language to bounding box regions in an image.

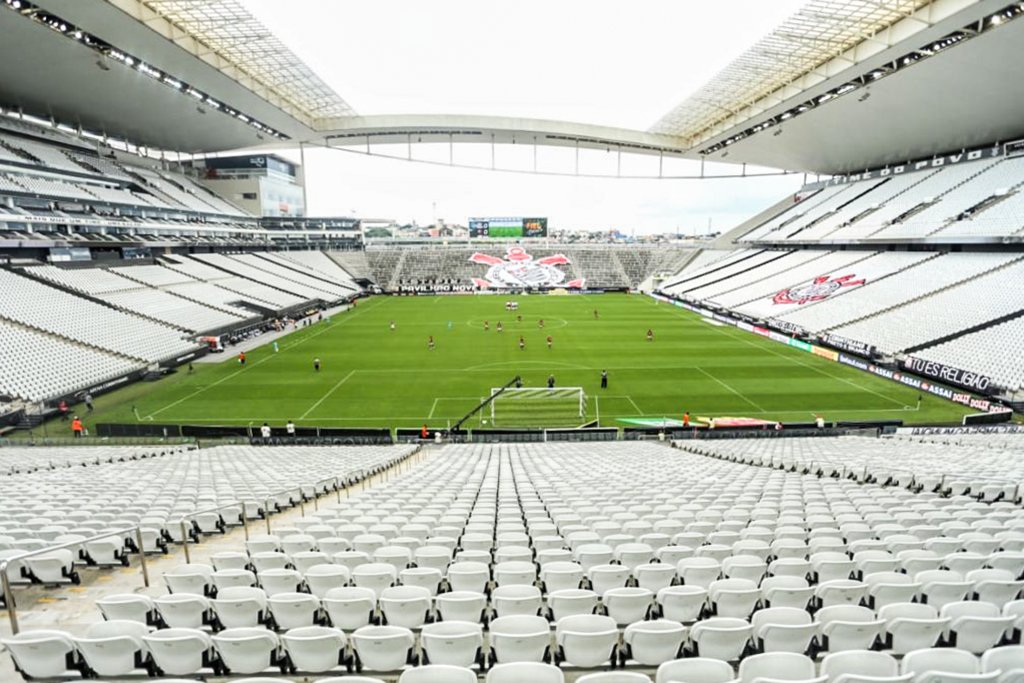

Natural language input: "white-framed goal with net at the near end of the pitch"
[490,387,587,427]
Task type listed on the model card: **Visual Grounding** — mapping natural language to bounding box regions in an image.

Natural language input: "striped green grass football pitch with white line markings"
[61,295,967,427]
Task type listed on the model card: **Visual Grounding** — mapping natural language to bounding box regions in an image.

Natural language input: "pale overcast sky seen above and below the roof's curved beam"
[237,0,803,233]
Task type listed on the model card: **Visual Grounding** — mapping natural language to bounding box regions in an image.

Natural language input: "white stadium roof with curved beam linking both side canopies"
[0,0,1024,173]
